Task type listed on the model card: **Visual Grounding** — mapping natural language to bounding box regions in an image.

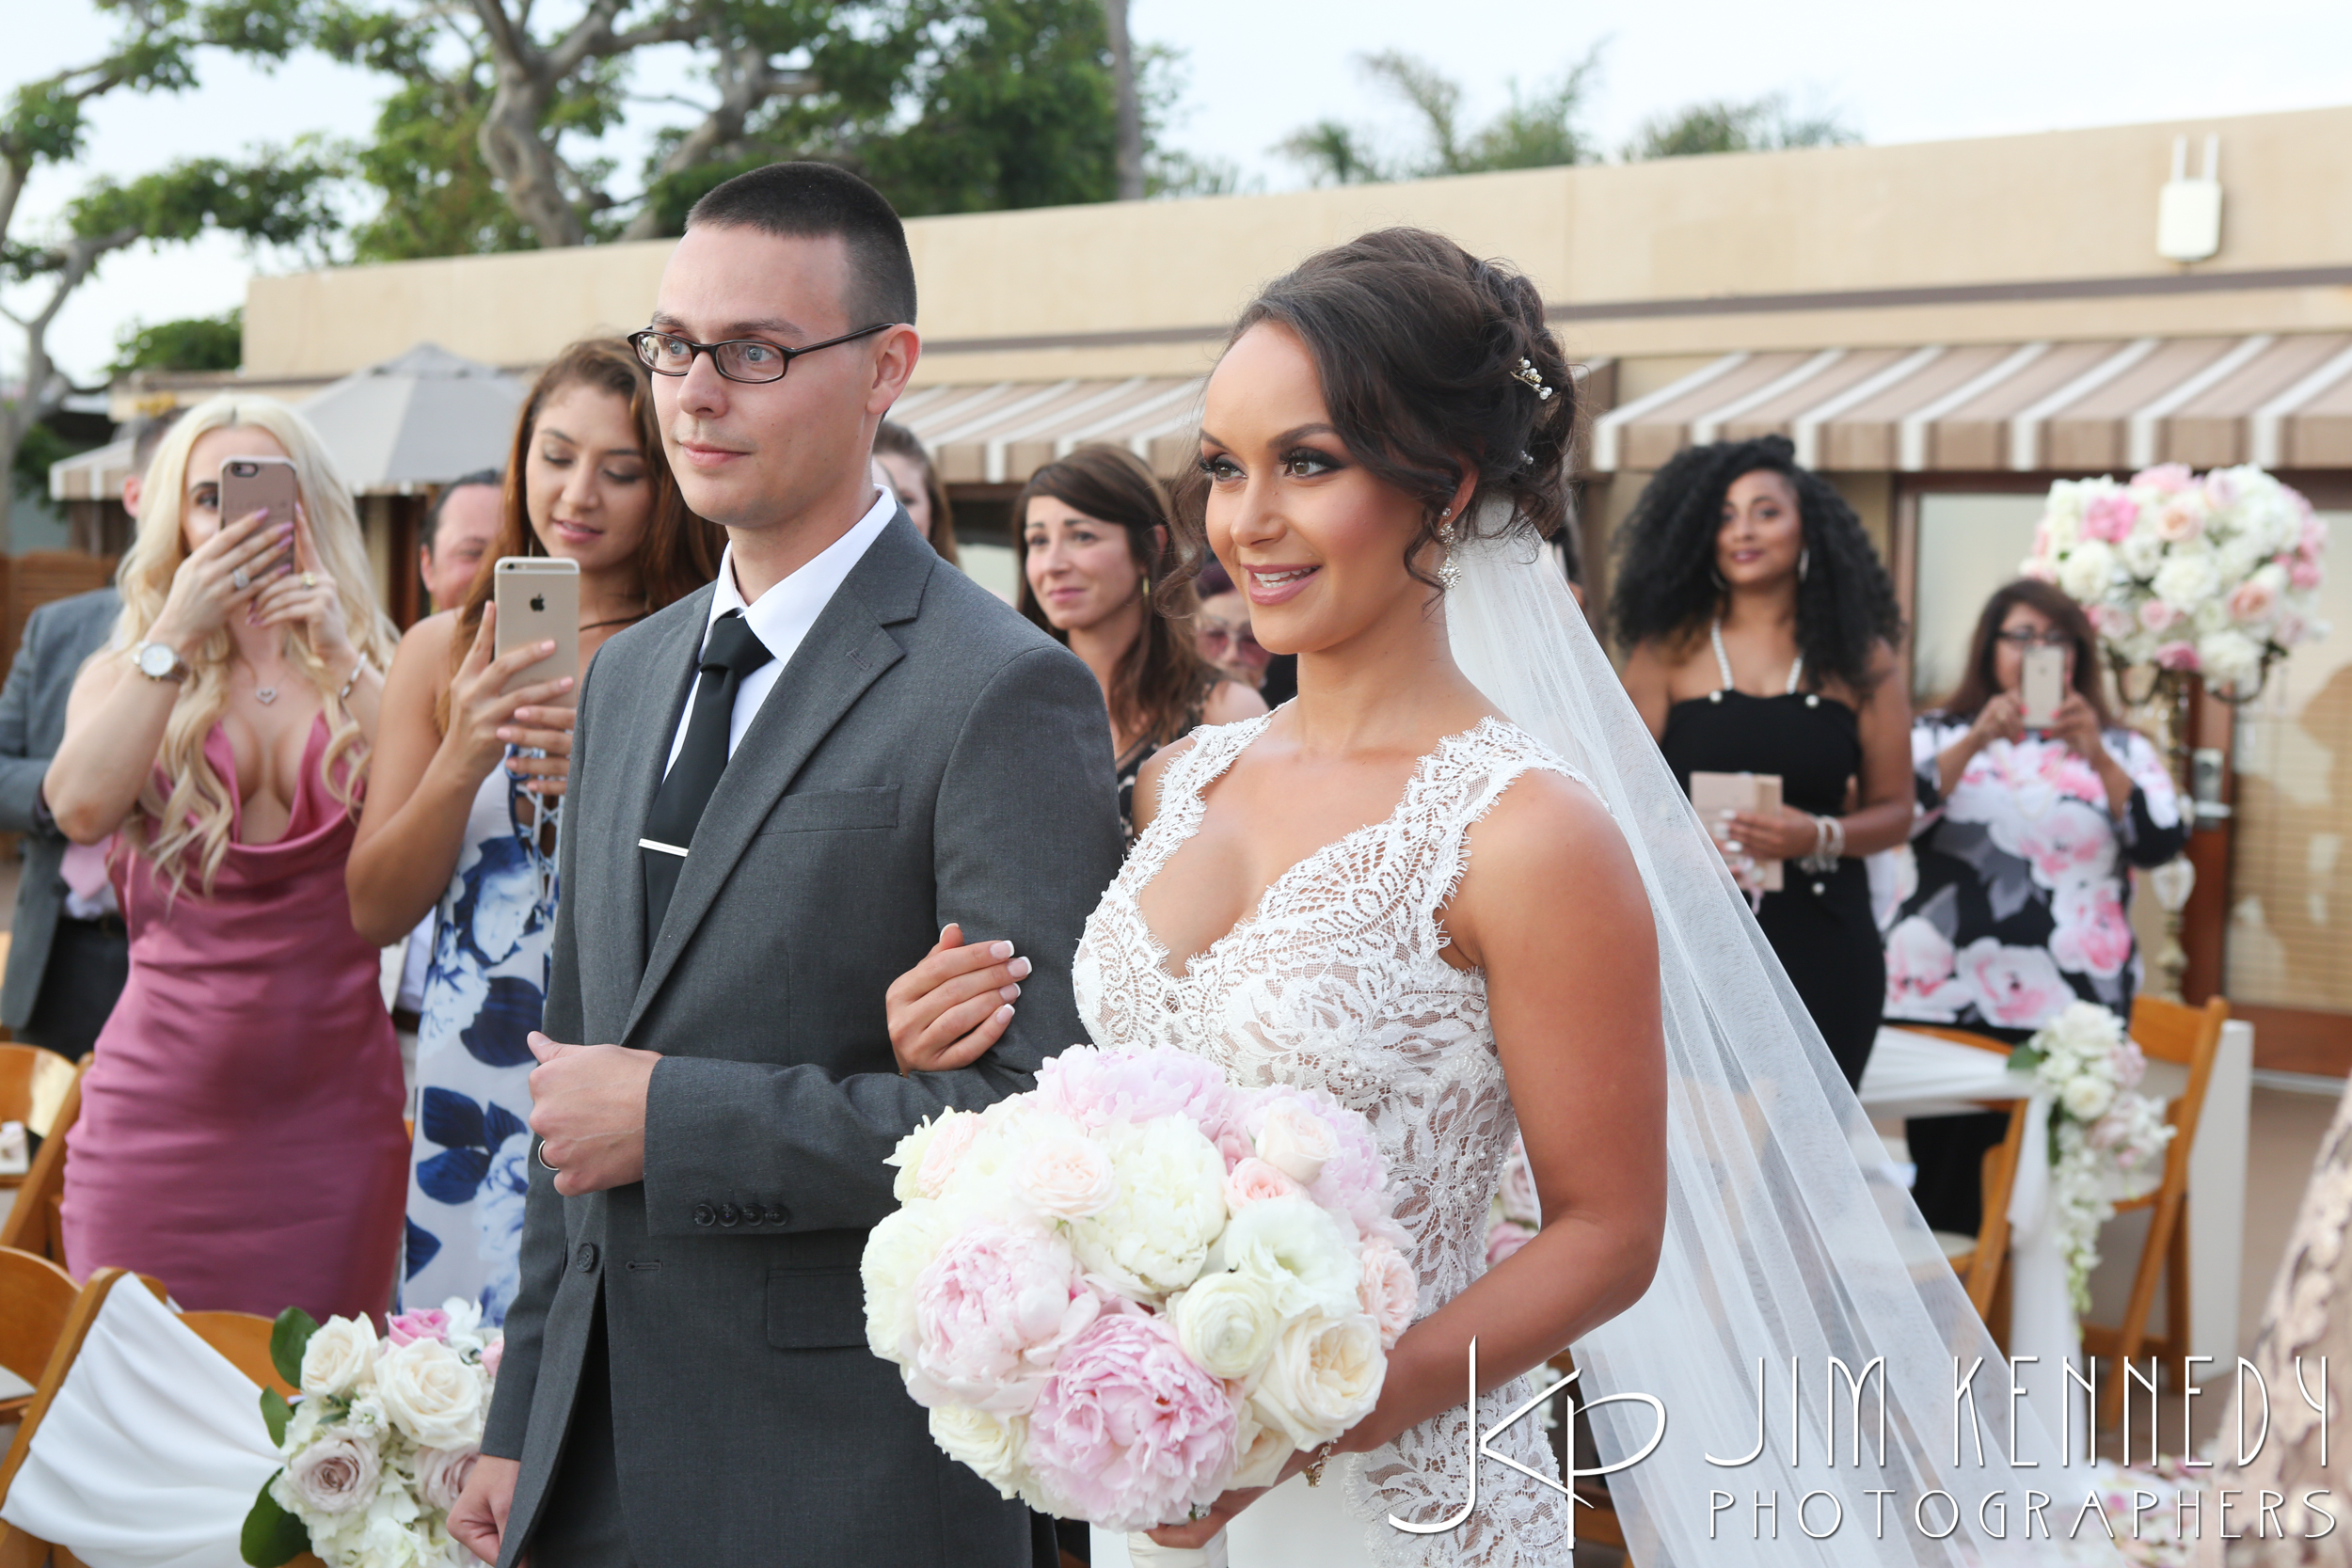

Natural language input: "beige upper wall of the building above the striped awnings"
[245,108,2352,381]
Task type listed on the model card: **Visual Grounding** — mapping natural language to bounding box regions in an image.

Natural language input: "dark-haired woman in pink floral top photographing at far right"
[1886,578,2187,1232]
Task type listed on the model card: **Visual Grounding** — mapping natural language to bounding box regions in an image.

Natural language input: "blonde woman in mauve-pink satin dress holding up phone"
[45,397,407,1319]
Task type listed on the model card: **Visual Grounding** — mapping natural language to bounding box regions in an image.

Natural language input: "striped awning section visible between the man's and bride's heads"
[889,376,1207,484]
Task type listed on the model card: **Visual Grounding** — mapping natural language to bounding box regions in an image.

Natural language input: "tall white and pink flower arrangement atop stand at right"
[2021,463,2328,696]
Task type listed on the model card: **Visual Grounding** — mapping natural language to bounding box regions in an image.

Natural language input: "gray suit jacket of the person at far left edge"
[0,588,122,1030]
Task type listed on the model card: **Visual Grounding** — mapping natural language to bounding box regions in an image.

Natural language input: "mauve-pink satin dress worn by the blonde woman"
[64,715,409,1322]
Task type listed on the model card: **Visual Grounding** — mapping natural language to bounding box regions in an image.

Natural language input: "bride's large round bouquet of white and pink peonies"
[861,1046,1419,1530]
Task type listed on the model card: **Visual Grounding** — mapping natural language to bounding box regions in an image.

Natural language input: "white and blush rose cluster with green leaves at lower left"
[240,1298,506,1568]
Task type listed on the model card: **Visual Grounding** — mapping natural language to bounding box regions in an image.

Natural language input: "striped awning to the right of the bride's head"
[1593,334,2352,472]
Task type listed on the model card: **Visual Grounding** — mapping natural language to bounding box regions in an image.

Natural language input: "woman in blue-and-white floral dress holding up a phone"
[351,339,718,1323]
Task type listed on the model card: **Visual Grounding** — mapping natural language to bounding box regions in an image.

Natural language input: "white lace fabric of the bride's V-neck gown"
[1073,715,1576,1568]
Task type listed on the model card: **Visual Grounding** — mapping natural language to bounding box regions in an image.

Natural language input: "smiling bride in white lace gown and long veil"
[889,228,2079,1568]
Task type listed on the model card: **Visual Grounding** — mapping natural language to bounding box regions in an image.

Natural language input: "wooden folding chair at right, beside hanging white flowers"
[2082,997,2230,1427]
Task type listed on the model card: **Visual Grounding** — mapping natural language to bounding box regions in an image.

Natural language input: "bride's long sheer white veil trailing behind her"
[1447,512,2120,1568]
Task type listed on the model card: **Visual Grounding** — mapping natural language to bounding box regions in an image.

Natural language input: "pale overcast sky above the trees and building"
[0,0,2352,381]
